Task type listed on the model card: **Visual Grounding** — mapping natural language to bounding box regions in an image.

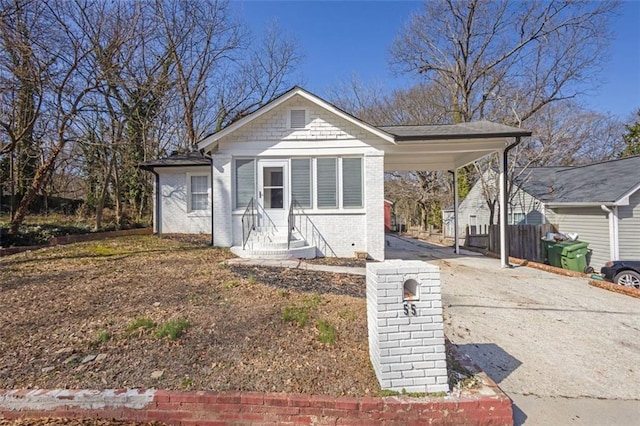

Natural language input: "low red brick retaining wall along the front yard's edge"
[0,384,513,426]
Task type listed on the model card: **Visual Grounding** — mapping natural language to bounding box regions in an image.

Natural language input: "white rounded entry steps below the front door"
[231,227,316,259]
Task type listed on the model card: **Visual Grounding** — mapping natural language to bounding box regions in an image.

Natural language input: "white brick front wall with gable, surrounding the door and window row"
[214,97,387,260]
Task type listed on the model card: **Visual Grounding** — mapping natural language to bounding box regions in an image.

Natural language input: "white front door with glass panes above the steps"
[258,160,289,228]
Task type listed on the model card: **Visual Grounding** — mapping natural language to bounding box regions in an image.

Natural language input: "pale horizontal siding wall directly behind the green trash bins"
[547,207,611,271]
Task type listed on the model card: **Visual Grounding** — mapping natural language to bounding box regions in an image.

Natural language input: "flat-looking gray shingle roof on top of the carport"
[378,121,531,142]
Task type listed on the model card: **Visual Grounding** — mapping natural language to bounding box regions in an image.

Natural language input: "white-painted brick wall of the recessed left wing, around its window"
[156,166,211,234]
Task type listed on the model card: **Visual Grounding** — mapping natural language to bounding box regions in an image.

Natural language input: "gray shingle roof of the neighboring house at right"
[516,155,640,205]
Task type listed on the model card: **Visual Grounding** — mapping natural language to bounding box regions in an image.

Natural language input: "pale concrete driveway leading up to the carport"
[386,235,640,425]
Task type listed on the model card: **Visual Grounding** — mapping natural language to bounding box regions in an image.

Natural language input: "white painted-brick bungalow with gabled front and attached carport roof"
[141,87,531,263]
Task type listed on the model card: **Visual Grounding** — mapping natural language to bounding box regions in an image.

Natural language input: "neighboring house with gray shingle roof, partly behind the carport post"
[452,156,640,270]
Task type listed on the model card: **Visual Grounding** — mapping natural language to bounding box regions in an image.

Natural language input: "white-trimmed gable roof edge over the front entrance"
[198,86,395,151]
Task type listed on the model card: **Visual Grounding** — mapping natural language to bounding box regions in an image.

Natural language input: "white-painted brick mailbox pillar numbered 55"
[367,260,449,393]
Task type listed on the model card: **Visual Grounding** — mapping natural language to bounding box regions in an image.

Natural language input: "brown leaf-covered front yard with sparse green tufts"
[0,236,379,396]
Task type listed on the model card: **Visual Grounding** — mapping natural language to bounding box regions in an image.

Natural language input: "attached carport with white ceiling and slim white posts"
[379,121,531,267]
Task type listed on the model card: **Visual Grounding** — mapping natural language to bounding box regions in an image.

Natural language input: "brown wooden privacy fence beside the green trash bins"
[487,223,556,263]
